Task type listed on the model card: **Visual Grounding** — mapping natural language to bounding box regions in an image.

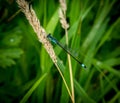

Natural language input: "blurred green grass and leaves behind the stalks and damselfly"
[0,0,120,103]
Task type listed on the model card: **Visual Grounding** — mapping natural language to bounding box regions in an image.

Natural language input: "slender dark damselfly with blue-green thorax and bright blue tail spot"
[47,34,86,68]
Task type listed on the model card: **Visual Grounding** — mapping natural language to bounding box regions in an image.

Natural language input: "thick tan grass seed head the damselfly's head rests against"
[17,0,57,63]
